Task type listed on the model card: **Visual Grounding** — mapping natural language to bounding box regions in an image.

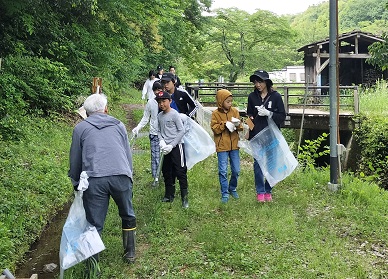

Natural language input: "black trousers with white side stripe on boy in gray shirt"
[162,143,188,198]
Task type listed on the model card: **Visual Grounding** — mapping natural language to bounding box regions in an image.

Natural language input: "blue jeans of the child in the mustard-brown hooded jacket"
[217,149,240,197]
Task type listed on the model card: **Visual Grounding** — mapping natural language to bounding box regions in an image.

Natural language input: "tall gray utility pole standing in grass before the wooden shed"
[329,0,339,191]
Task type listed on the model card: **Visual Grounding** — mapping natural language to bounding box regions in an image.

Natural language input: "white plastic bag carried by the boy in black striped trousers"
[180,113,216,170]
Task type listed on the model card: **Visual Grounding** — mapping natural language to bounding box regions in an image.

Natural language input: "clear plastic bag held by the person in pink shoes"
[249,118,298,187]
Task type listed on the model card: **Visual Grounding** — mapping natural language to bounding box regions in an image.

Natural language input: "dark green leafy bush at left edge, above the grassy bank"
[0,56,77,117]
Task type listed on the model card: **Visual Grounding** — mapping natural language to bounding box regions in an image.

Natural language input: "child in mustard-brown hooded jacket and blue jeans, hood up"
[210,89,243,203]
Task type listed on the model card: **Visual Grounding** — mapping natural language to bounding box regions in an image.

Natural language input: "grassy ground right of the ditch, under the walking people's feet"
[66,91,388,278]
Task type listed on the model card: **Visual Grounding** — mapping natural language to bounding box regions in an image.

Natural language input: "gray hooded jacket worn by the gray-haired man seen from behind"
[68,113,132,185]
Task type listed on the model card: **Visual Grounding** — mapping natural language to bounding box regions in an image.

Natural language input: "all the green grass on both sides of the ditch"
[0,87,388,279]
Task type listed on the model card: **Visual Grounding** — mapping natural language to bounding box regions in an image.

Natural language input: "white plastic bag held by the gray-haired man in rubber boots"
[59,191,105,271]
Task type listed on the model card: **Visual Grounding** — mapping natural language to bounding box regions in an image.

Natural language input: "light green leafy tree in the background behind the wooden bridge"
[203,9,297,82]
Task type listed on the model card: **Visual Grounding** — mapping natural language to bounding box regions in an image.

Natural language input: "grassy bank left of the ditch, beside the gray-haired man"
[0,116,73,270]
